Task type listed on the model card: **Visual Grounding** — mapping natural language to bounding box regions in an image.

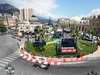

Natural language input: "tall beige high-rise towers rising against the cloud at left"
[19,8,33,21]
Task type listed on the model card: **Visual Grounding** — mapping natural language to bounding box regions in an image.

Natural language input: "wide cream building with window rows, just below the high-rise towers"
[17,16,43,32]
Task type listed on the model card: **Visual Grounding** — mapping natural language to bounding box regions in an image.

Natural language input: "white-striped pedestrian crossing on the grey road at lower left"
[0,50,20,69]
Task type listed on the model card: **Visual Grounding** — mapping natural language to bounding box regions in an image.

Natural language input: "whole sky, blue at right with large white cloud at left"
[0,0,100,19]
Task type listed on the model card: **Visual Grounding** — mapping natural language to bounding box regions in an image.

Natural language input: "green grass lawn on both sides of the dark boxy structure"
[25,39,96,57]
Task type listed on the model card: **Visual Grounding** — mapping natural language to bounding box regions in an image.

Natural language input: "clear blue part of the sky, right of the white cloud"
[53,0,100,16]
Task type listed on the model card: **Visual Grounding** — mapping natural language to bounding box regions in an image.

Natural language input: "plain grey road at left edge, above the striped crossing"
[0,34,18,58]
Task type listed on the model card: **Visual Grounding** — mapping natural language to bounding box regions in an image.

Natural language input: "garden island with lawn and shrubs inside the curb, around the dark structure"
[25,27,97,58]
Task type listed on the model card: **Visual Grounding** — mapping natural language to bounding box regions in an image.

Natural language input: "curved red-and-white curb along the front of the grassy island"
[20,48,86,65]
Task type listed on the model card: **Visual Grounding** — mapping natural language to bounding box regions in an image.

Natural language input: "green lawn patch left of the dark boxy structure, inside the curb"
[25,42,56,57]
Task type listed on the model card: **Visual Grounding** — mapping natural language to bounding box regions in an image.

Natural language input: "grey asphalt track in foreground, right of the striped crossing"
[9,58,100,75]
